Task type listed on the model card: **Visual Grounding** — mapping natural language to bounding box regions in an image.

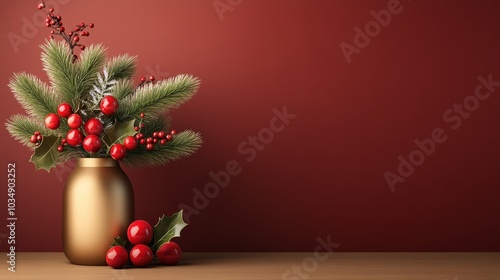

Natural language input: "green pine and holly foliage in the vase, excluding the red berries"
[6,40,202,170]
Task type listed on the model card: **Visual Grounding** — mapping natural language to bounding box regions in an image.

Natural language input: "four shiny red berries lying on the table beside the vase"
[106,220,182,268]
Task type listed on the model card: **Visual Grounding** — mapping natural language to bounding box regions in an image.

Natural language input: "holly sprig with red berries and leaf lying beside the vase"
[106,210,187,268]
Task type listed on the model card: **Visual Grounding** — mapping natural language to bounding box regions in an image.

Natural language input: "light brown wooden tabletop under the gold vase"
[0,253,500,280]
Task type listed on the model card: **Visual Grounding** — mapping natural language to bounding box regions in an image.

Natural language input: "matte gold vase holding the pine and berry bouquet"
[62,158,135,265]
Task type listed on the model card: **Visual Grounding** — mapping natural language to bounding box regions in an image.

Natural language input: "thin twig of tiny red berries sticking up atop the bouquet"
[38,1,94,61]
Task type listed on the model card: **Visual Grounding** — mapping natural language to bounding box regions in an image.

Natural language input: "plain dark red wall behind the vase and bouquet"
[0,0,500,251]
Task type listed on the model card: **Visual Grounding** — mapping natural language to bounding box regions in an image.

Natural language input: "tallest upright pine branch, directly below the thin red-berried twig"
[42,40,77,104]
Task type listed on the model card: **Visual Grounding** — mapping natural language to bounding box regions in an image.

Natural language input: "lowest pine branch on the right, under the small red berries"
[123,130,203,167]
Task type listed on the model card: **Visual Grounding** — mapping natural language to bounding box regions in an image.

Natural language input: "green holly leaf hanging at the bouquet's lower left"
[30,135,59,172]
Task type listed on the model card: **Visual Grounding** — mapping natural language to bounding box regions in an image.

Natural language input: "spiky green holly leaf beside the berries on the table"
[152,209,187,250]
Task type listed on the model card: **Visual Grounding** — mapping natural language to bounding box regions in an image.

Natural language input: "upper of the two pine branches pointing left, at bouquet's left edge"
[9,73,60,120]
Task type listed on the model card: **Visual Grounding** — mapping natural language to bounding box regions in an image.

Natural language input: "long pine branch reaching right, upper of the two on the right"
[116,75,200,121]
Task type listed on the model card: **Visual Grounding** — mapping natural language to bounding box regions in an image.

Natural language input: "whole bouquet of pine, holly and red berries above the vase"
[6,2,202,171]
